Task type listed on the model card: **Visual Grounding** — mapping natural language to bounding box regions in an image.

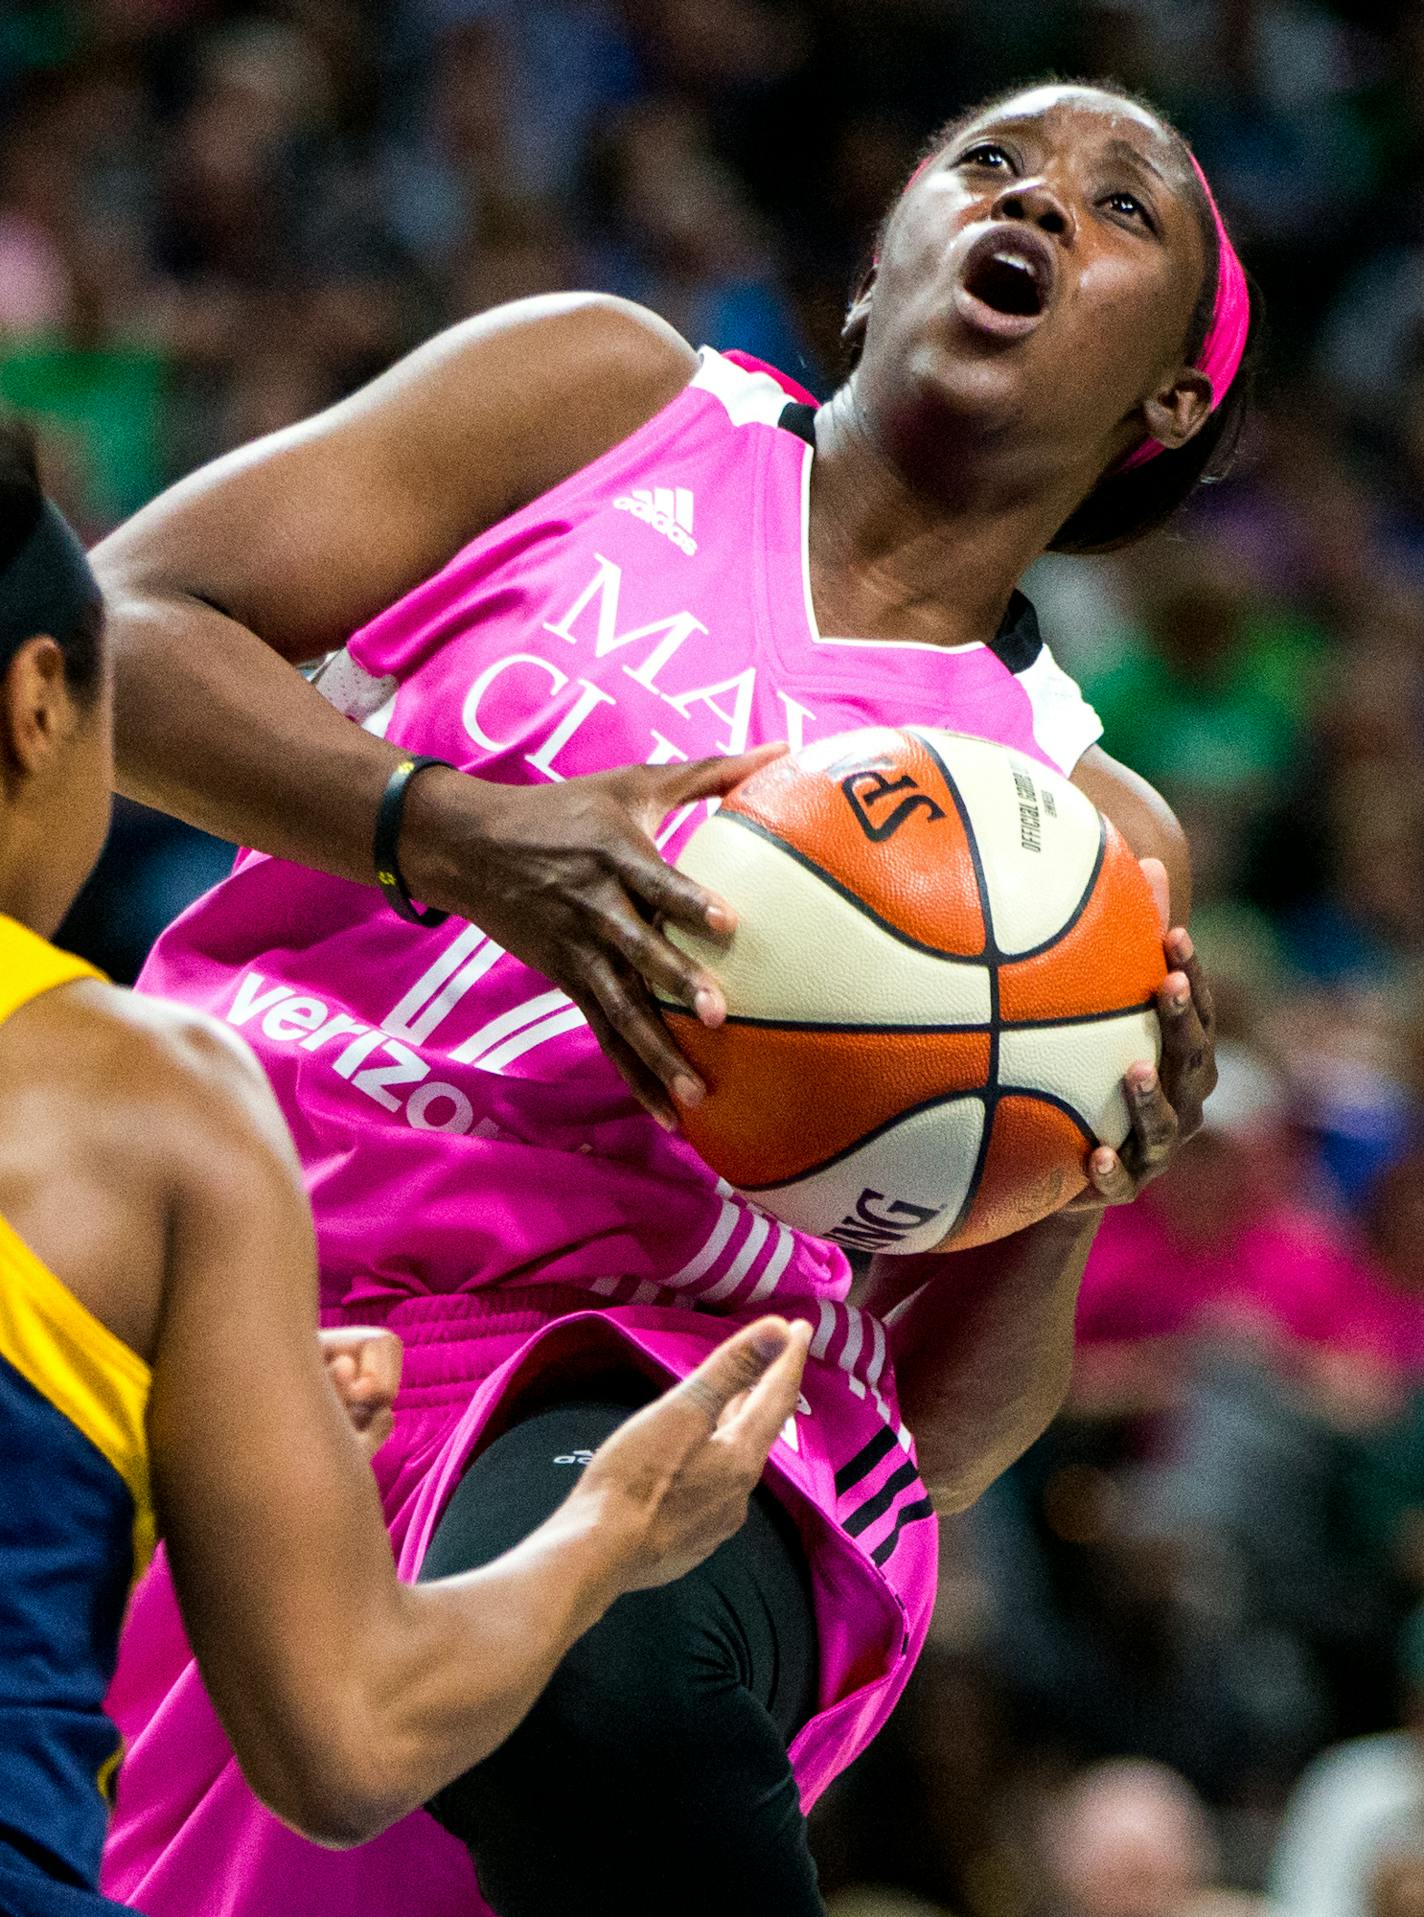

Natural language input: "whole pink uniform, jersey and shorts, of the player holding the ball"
[107,351,1100,1917]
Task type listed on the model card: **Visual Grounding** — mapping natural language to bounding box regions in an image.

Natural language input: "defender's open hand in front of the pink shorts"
[573,1317,811,1591]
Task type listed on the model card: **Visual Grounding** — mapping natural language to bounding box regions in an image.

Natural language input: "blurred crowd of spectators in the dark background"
[11,0,1424,1917]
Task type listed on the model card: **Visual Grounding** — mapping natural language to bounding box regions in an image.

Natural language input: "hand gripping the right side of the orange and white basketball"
[1064,859,1217,1212]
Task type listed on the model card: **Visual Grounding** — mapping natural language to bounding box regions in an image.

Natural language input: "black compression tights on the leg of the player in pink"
[422,1397,824,1917]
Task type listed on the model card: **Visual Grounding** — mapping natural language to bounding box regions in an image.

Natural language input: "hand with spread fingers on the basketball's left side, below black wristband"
[401,746,786,1129]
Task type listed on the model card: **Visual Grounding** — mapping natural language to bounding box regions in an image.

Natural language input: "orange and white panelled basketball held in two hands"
[665,727,1165,1252]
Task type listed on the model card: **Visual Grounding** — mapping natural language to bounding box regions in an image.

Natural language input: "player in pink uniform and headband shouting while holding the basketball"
[100,84,1250,1917]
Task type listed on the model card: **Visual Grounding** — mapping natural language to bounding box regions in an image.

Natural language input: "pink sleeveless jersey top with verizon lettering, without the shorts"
[144,353,1098,1334]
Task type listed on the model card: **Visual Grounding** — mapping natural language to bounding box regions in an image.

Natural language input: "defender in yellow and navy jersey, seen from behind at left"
[0,415,807,1917]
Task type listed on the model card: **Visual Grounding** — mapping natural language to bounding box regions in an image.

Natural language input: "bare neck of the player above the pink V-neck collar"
[809,387,1066,646]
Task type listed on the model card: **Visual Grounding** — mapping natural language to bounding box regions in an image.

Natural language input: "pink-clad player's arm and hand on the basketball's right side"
[864,748,1215,1511]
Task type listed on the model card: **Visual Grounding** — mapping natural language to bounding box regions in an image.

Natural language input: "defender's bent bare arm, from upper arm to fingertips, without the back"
[149,1020,807,1844]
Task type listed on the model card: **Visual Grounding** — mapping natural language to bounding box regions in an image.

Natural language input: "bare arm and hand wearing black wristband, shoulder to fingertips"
[94,295,757,1123]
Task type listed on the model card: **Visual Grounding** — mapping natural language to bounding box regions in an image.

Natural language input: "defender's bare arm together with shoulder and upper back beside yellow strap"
[0,983,807,1844]
